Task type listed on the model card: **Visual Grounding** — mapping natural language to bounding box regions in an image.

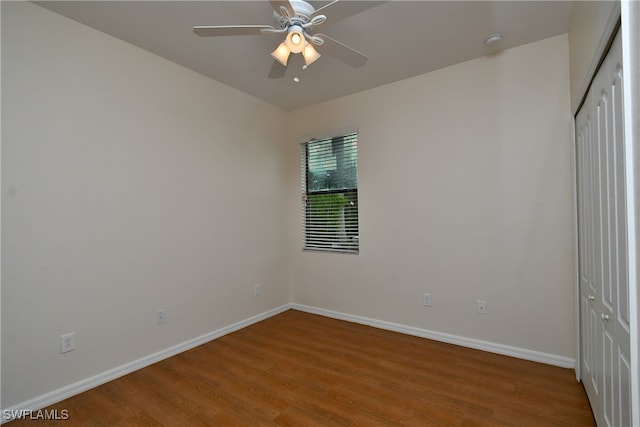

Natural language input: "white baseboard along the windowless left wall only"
[0,304,291,424]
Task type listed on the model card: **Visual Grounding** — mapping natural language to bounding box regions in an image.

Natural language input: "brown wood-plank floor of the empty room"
[9,310,595,427]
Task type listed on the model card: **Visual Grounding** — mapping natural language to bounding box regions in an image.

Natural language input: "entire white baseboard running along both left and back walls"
[0,303,575,424]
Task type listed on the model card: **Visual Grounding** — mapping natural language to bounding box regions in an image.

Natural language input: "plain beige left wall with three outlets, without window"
[2,2,288,408]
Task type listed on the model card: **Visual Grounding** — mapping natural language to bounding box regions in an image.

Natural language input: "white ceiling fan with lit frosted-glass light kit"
[193,0,380,78]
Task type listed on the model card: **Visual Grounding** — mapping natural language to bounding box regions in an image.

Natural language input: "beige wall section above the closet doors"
[569,0,620,113]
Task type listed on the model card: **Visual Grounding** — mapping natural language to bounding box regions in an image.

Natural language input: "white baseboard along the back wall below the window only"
[291,303,575,369]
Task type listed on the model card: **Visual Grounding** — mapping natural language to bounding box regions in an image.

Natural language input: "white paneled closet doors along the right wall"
[576,31,631,426]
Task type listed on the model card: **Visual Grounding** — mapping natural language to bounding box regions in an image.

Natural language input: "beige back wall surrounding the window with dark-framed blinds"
[287,35,575,358]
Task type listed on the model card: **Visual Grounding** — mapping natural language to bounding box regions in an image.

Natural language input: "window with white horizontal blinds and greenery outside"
[301,133,359,253]
